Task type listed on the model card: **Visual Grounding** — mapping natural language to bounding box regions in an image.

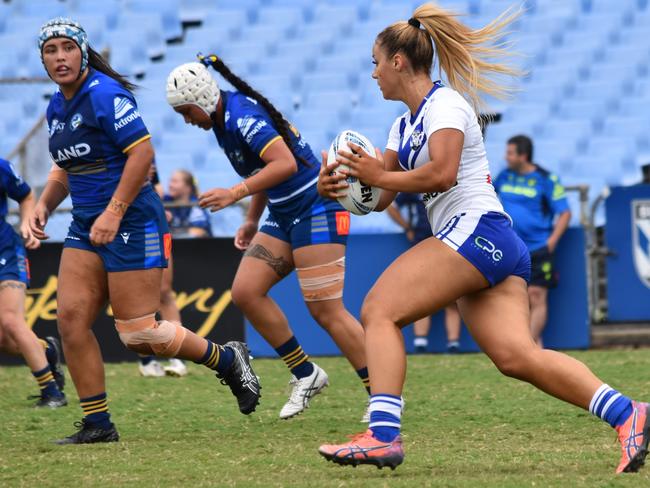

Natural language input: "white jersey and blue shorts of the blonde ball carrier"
[386,81,530,286]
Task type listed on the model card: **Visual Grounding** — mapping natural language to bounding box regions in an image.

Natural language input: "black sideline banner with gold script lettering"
[0,239,244,364]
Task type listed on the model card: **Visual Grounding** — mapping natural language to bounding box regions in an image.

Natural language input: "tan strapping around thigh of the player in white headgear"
[296,256,345,302]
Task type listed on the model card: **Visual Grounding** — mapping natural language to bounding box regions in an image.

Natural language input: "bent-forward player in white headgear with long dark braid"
[167,55,368,419]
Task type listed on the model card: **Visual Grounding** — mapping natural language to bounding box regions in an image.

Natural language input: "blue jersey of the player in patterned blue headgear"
[47,69,151,207]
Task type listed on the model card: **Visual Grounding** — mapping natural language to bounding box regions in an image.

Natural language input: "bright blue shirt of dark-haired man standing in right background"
[494,166,569,251]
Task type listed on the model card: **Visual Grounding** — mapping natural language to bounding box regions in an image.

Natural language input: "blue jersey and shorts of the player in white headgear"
[213,91,350,249]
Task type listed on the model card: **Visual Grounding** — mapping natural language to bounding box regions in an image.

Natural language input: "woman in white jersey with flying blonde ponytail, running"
[319,4,648,473]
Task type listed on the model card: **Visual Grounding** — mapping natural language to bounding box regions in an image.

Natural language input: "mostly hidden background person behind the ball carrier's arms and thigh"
[386,193,460,354]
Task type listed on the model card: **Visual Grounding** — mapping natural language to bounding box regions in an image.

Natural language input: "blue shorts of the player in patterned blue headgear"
[63,187,172,273]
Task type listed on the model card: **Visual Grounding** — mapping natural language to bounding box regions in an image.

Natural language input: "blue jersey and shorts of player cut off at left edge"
[0,159,32,285]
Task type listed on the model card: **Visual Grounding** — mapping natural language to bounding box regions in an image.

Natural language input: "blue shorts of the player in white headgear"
[260,185,350,249]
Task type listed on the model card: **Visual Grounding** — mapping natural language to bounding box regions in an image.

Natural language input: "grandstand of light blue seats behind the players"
[0,0,650,235]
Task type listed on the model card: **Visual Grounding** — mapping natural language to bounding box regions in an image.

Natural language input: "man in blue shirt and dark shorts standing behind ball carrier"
[494,135,571,346]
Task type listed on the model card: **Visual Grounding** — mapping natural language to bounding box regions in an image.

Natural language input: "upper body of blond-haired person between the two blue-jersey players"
[163,169,212,238]
